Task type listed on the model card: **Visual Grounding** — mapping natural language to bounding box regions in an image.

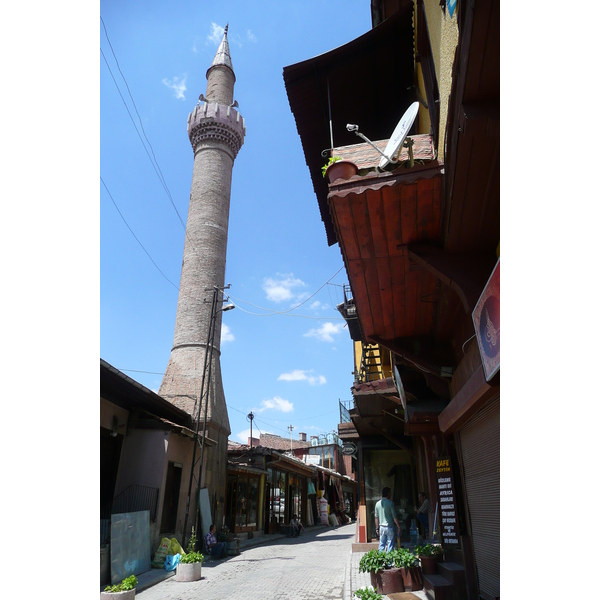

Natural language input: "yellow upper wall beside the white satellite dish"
[415,0,458,160]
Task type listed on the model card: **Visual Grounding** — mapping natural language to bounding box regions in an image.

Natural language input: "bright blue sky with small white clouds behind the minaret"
[98,0,371,441]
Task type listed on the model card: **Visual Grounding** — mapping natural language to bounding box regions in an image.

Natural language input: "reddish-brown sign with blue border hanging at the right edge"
[472,259,500,381]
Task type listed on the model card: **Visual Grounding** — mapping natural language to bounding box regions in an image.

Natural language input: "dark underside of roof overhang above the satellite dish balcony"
[283,0,417,246]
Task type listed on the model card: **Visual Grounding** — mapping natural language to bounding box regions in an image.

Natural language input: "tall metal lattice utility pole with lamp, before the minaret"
[182,284,235,547]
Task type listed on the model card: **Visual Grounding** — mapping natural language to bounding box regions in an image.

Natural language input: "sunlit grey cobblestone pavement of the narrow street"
[136,523,358,600]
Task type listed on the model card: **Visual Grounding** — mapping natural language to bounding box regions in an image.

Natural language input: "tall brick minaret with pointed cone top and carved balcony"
[158,27,246,526]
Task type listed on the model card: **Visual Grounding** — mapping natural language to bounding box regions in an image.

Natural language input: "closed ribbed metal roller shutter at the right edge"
[460,394,500,599]
